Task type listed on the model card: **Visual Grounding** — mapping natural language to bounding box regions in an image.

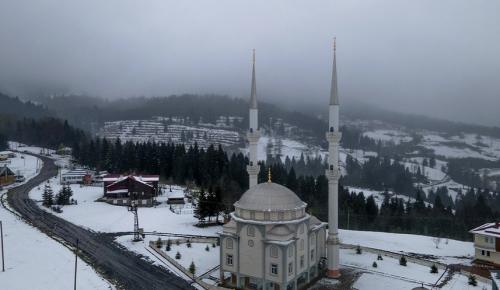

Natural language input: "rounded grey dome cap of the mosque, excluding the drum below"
[234,182,306,211]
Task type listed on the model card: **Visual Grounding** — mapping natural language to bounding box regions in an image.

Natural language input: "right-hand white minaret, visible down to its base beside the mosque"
[325,39,342,278]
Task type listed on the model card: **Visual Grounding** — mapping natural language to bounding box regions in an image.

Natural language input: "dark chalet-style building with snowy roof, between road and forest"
[103,175,160,206]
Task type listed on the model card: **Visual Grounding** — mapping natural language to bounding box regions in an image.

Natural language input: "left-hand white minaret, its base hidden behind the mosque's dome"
[247,49,260,187]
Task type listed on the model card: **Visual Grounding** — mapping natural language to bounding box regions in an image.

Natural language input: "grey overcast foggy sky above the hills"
[0,0,500,126]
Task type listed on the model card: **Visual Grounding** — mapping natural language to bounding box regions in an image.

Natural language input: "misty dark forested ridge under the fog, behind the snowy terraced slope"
[27,95,326,136]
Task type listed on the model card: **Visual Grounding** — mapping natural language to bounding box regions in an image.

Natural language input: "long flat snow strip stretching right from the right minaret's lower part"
[339,230,474,264]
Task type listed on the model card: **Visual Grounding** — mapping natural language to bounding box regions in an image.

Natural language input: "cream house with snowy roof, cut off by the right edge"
[469,222,500,266]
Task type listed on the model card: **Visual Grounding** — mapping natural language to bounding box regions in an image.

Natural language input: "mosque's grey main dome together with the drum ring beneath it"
[234,182,307,221]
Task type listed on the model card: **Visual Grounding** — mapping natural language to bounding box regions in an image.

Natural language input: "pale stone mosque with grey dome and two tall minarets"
[219,43,341,290]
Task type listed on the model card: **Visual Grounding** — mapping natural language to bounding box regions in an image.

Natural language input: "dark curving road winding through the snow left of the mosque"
[7,154,194,290]
